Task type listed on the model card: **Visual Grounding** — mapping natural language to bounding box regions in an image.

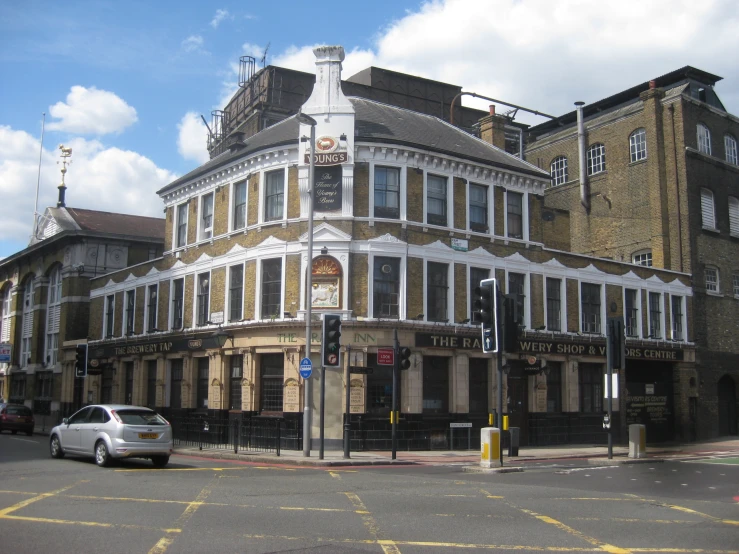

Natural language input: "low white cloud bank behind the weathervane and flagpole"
[0,125,177,250]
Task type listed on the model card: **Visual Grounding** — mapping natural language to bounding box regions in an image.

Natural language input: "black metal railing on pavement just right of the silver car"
[169,415,284,456]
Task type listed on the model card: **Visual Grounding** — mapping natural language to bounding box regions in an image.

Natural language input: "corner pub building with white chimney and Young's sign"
[87,46,694,450]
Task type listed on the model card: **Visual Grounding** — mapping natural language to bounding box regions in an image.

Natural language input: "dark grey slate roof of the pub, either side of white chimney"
[157,97,549,195]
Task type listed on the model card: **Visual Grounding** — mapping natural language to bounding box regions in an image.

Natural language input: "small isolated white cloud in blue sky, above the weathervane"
[46,85,138,135]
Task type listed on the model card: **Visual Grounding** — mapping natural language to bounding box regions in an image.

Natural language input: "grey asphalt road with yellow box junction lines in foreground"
[0,434,739,554]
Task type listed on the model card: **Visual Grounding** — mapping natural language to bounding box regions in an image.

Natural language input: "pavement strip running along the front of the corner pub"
[30,422,739,468]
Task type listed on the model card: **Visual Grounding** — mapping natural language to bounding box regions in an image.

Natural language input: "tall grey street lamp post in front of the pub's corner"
[297,112,316,457]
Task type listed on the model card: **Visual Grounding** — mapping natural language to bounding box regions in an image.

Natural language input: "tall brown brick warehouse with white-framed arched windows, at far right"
[526,67,739,439]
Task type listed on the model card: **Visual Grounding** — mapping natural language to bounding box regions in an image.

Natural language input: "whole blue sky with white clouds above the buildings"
[0,0,739,258]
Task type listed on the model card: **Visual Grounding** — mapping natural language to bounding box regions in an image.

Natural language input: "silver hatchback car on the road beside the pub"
[49,404,173,467]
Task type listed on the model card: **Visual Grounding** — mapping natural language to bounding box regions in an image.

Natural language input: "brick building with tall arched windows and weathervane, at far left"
[0,197,164,416]
